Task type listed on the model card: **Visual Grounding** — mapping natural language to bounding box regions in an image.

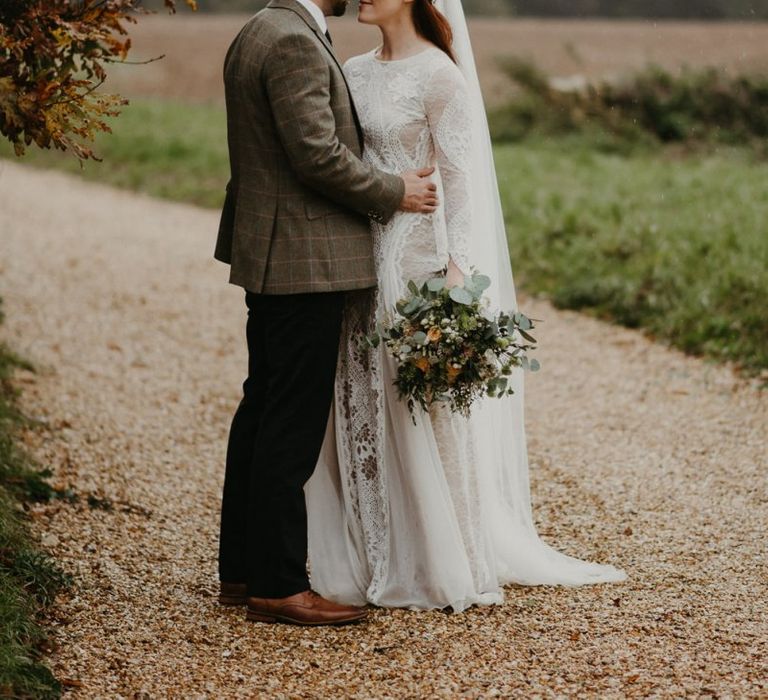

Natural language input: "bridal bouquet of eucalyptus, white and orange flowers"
[366,272,539,416]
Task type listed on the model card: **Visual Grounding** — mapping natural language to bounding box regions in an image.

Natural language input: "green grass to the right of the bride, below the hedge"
[496,139,768,372]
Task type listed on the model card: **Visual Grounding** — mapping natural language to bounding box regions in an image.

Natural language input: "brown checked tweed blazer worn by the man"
[214,0,404,294]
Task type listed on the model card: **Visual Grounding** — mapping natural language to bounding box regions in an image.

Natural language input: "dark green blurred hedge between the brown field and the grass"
[491,59,768,153]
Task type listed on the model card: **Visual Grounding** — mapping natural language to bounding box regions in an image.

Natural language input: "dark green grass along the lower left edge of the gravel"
[0,302,70,698]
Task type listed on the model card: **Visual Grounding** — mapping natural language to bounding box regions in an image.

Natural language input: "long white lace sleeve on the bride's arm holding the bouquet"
[424,63,472,274]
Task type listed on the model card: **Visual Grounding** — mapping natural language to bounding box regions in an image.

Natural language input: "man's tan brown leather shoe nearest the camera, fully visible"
[245,590,368,625]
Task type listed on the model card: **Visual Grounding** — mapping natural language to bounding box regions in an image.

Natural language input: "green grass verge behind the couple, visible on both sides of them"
[6,100,768,371]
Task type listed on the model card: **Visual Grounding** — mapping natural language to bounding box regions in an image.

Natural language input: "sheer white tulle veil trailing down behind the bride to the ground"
[435,0,626,585]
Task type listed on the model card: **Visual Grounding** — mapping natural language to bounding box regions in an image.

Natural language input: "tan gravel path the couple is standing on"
[0,161,768,698]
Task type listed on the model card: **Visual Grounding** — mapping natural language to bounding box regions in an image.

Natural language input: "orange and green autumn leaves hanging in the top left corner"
[0,0,194,159]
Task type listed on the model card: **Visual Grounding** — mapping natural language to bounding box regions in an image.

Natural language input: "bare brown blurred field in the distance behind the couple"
[100,15,768,106]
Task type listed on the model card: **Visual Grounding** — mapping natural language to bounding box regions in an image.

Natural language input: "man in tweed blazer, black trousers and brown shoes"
[215,0,437,625]
